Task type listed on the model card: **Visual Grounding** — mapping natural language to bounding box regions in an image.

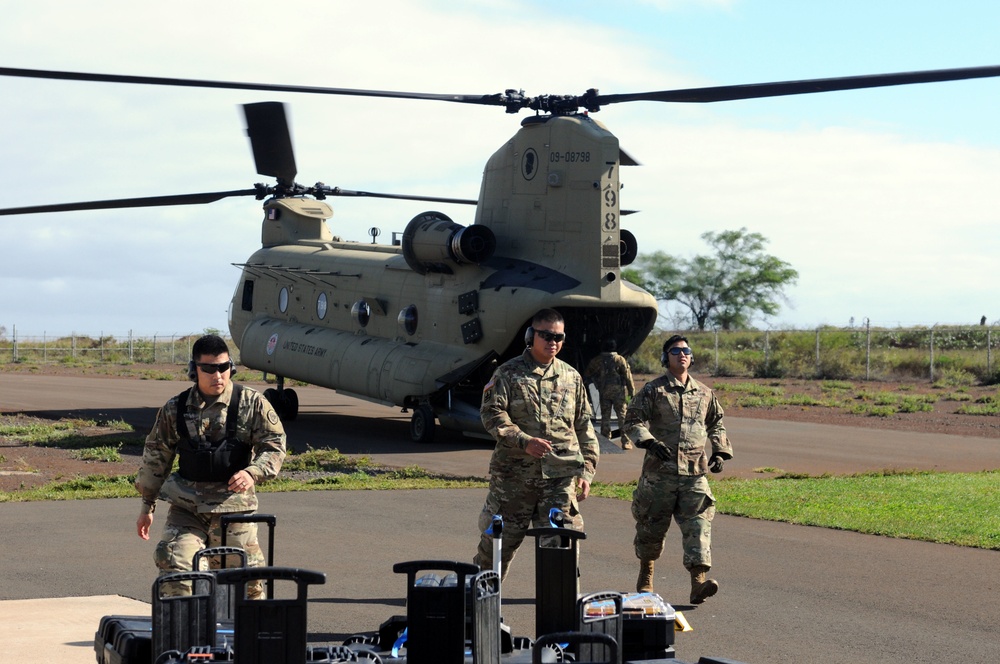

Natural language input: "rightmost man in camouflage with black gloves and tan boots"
[625,335,733,604]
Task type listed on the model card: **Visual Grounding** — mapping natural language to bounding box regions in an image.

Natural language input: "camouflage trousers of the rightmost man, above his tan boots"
[632,475,715,569]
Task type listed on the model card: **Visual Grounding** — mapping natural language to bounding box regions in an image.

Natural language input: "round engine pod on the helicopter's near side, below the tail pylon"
[402,212,497,274]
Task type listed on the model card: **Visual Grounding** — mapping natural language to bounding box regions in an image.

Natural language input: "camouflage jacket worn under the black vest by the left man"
[135,383,285,513]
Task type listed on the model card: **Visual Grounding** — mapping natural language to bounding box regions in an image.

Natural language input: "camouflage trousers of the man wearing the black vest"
[153,505,266,599]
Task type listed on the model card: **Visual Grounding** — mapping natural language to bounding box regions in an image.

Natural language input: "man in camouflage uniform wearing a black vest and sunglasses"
[135,335,285,598]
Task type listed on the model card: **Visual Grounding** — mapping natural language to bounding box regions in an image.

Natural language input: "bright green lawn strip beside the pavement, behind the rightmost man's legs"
[593,471,1000,550]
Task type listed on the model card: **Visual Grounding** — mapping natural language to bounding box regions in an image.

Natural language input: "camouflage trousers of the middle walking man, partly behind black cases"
[473,474,583,579]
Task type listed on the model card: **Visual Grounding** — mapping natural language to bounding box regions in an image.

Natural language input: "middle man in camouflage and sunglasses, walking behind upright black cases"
[474,309,600,578]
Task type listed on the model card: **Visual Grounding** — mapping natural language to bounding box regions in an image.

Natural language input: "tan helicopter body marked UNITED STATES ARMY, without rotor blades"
[229,116,657,431]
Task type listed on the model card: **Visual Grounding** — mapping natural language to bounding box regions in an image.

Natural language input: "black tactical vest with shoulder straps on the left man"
[176,385,250,482]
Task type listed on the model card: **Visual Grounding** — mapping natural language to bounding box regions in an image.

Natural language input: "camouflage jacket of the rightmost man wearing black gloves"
[624,373,733,475]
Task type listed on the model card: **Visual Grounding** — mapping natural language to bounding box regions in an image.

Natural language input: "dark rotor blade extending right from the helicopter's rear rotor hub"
[595,66,1000,105]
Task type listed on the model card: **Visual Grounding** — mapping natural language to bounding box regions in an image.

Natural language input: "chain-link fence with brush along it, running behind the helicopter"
[0,325,1000,384]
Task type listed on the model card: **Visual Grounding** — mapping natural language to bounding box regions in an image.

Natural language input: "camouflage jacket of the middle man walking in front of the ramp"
[479,350,601,482]
